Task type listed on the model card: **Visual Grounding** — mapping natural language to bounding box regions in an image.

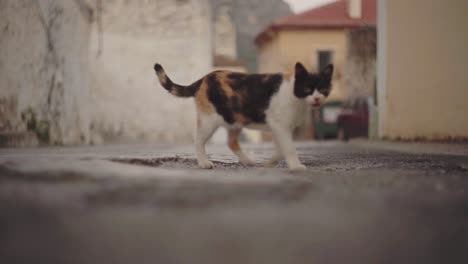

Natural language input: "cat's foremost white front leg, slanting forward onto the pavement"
[270,124,306,171]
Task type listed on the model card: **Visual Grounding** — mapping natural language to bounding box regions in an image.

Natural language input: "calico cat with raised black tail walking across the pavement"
[154,62,333,171]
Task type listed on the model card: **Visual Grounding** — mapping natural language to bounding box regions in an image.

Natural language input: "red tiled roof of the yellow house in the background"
[255,0,377,45]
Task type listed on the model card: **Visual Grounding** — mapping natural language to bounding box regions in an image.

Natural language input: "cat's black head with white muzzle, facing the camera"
[294,62,333,107]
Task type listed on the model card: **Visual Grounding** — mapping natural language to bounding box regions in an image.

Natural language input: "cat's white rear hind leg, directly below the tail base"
[195,114,219,169]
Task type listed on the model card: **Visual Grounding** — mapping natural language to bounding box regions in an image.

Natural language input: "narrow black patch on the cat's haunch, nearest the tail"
[206,73,235,124]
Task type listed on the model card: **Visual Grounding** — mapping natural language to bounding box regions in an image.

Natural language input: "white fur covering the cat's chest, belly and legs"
[195,78,308,171]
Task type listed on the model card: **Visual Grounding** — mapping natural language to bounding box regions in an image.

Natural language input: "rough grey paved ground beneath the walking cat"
[0,141,468,263]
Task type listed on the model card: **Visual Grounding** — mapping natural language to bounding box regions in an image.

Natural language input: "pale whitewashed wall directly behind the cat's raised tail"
[91,0,212,143]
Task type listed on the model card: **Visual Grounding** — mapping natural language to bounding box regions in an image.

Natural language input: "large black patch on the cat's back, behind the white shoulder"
[227,73,283,123]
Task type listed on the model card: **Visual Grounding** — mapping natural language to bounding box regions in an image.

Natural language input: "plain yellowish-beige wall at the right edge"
[378,0,468,139]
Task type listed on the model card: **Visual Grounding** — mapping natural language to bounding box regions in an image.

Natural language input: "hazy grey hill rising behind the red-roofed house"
[210,0,292,72]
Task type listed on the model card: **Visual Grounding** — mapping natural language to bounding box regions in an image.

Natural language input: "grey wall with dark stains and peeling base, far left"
[0,0,91,144]
